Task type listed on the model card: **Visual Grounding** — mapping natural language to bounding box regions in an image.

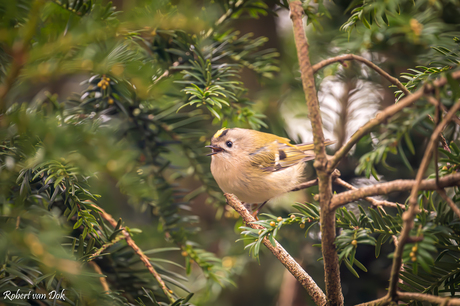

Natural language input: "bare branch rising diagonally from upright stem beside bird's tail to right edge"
[328,71,460,172]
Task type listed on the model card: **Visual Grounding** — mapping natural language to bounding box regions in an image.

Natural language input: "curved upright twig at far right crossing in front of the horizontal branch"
[388,101,460,300]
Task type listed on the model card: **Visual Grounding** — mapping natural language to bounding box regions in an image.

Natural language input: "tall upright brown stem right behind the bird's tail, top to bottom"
[289,0,343,306]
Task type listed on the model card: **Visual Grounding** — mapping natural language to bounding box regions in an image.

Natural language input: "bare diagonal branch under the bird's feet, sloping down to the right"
[224,193,326,305]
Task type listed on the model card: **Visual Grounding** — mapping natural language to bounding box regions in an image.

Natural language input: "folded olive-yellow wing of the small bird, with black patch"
[249,140,334,172]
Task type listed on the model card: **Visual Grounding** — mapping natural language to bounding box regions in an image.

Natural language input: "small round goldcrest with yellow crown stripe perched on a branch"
[206,128,334,214]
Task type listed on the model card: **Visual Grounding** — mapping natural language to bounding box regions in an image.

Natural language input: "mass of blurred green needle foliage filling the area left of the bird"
[0,0,278,305]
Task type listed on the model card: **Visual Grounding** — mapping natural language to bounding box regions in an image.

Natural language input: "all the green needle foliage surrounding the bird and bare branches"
[0,0,460,305]
